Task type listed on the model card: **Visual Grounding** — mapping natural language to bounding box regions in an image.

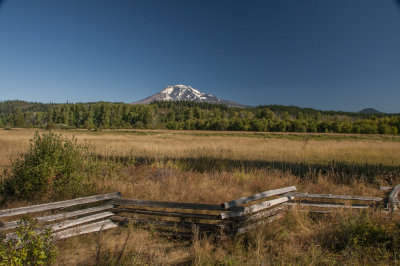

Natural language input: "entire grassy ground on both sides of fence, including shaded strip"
[0,130,400,265]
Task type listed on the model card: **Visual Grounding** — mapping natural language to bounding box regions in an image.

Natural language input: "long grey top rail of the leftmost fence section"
[0,192,121,218]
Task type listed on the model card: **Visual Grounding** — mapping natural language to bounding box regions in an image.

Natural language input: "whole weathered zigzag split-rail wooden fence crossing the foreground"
[0,184,400,239]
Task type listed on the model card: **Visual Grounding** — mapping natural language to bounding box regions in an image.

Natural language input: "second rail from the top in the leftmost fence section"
[0,205,114,231]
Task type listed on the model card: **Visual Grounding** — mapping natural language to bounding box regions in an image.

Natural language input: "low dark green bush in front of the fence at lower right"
[315,211,400,265]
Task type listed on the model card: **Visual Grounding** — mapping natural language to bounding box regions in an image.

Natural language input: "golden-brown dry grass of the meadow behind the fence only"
[0,129,394,204]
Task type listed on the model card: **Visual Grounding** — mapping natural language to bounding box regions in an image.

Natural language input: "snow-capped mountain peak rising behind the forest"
[134,85,244,107]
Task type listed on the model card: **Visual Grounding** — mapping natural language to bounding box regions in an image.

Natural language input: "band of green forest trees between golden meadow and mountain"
[0,100,400,135]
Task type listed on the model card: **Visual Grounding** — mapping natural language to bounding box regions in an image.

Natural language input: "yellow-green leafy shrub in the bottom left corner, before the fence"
[0,219,57,266]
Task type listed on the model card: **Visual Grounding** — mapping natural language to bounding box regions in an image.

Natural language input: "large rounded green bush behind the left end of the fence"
[2,132,87,199]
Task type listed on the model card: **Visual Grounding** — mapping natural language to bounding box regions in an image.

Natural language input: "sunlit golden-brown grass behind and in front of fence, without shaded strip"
[0,130,400,265]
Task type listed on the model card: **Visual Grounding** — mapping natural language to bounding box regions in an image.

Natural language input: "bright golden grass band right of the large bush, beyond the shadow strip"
[77,133,400,165]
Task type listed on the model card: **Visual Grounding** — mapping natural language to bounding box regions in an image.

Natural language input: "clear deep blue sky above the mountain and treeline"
[0,0,400,113]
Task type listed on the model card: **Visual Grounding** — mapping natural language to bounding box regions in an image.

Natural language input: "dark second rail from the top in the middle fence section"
[112,208,221,220]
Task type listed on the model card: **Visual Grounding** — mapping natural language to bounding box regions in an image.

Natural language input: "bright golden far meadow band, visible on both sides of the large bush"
[0,130,400,166]
